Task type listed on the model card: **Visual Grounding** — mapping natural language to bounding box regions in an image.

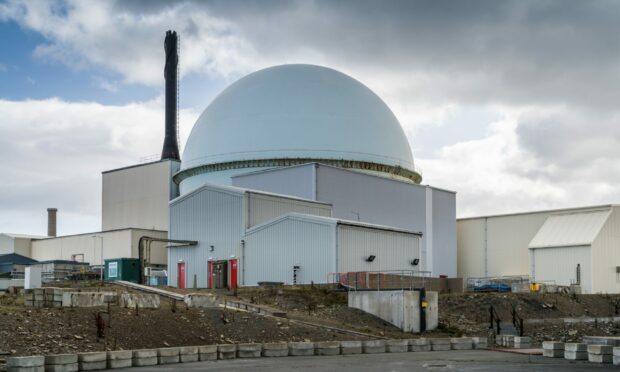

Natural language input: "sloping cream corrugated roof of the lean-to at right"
[529,210,611,249]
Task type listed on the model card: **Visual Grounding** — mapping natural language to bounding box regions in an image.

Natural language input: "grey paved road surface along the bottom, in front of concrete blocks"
[119,350,613,372]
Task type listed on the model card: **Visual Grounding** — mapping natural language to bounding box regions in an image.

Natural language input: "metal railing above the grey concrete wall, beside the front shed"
[327,270,431,291]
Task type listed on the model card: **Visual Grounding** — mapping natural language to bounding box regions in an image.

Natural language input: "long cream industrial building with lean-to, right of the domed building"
[457,205,620,293]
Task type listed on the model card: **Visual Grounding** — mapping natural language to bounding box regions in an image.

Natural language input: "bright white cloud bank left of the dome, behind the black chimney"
[0,98,197,234]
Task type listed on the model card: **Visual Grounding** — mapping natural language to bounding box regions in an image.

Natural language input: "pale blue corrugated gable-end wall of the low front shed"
[245,218,336,285]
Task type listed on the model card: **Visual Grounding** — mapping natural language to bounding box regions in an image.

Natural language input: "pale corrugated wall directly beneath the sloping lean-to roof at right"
[530,246,592,293]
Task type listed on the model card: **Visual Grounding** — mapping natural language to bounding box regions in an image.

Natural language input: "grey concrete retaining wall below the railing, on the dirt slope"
[349,291,439,333]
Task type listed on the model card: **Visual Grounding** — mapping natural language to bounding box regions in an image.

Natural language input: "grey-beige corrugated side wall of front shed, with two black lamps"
[337,225,420,272]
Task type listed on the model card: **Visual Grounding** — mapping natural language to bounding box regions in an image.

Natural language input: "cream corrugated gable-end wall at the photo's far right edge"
[592,206,620,293]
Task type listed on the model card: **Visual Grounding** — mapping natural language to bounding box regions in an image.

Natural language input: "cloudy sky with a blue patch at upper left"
[0,0,620,234]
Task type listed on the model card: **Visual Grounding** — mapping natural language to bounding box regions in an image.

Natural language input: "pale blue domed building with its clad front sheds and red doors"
[168,65,456,288]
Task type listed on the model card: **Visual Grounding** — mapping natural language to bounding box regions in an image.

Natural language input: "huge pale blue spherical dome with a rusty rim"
[175,65,421,191]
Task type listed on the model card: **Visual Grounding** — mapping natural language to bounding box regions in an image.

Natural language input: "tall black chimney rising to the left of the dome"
[161,30,180,160]
